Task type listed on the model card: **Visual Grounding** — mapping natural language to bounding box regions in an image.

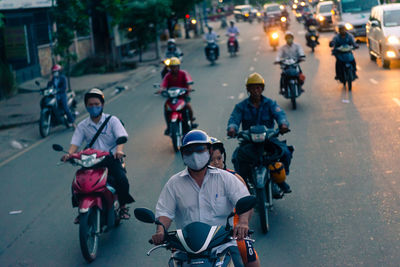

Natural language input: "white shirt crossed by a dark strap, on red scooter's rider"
[71,113,128,152]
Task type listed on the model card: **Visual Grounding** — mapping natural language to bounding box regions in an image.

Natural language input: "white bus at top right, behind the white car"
[333,0,380,37]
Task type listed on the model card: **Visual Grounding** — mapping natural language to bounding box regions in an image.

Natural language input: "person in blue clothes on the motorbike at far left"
[47,64,75,127]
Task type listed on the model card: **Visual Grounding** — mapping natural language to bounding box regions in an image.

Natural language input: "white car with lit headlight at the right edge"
[366,4,400,68]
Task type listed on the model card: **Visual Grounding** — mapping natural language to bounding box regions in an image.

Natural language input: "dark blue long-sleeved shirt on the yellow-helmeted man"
[228,96,289,131]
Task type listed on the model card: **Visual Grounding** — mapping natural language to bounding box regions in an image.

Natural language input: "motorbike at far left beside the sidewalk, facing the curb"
[35,81,76,137]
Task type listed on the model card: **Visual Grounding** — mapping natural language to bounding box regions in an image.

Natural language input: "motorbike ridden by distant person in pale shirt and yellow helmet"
[276,58,303,110]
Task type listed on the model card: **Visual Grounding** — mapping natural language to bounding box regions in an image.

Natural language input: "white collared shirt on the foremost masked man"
[156,166,249,229]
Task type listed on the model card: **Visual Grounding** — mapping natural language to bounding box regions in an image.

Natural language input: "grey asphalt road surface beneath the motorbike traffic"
[0,17,400,266]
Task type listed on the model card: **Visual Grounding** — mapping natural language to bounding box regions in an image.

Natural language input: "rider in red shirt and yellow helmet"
[157,57,197,135]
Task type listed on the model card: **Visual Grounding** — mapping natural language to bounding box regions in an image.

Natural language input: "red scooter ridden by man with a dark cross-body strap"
[53,137,127,262]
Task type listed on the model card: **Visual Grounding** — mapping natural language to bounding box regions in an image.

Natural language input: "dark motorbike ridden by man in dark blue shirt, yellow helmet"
[235,125,284,234]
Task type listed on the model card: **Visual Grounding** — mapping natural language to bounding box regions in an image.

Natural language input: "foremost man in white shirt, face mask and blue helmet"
[152,130,252,266]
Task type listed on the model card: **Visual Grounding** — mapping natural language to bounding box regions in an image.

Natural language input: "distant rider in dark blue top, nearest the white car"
[329,23,358,80]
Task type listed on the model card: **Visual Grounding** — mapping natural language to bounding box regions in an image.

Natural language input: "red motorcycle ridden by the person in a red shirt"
[161,87,194,152]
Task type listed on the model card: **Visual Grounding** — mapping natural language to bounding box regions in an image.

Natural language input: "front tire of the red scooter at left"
[79,208,100,262]
